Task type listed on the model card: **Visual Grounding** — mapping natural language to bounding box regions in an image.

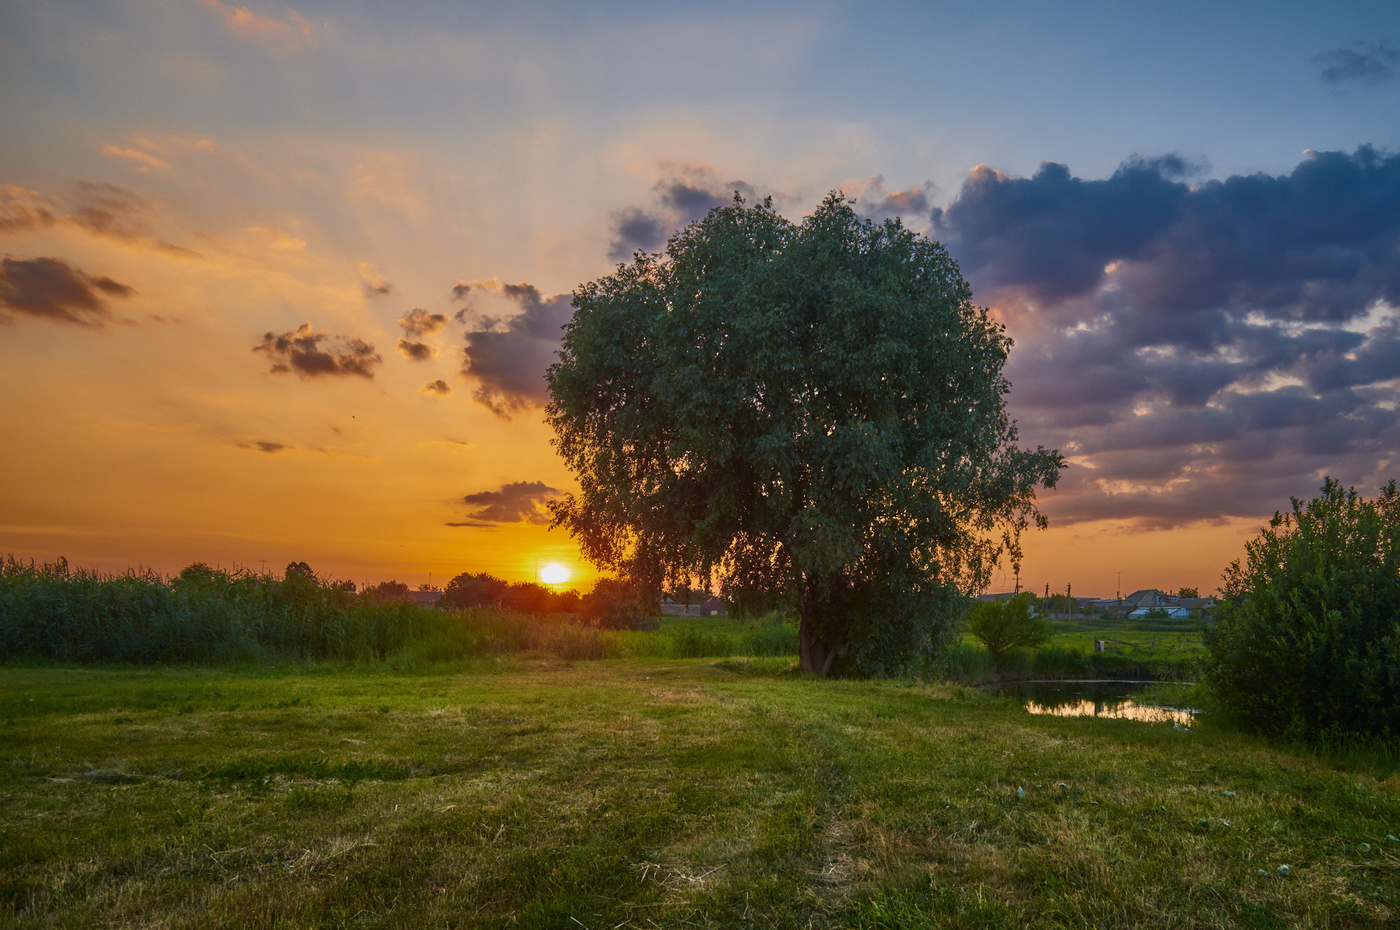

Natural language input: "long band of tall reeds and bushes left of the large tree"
[0,556,761,664]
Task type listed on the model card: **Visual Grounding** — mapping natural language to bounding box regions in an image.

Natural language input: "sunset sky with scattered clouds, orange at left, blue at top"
[0,0,1400,595]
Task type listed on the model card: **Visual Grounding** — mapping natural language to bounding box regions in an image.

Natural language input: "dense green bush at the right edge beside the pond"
[1205,478,1400,742]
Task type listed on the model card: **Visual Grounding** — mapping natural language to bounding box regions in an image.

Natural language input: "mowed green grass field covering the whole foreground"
[0,657,1400,930]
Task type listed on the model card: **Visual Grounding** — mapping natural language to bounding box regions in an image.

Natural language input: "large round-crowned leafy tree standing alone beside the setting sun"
[549,193,1064,675]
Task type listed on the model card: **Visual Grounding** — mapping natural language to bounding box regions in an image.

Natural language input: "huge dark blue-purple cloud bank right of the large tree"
[932,147,1400,527]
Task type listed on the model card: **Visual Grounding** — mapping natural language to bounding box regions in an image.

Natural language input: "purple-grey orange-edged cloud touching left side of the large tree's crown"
[459,277,574,419]
